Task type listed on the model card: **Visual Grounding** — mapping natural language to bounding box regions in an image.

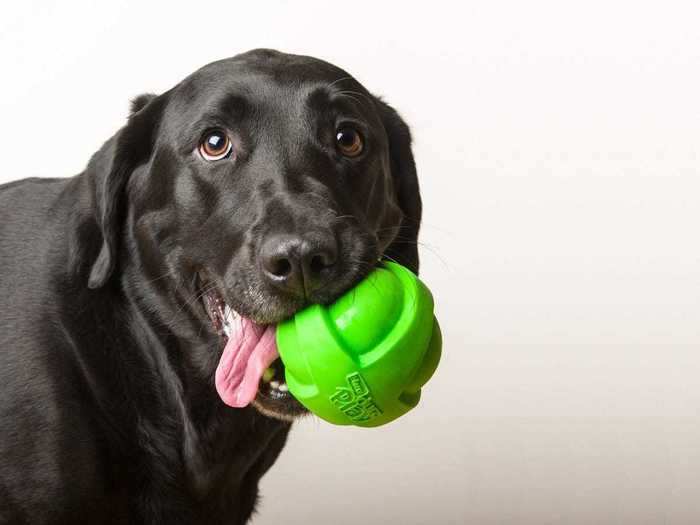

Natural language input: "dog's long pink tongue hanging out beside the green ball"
[216,315,279,408]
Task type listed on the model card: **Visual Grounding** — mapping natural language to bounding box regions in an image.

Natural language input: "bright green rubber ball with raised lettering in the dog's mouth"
[277,262,442,427]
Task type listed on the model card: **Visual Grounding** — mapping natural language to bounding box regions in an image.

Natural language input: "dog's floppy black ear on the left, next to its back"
[87,94,167,289]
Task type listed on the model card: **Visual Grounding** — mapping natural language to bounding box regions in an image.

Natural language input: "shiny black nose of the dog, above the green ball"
[260,232,338,297]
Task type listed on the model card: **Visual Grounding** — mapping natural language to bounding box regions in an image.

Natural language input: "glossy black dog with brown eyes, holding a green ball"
[0,50,421,524]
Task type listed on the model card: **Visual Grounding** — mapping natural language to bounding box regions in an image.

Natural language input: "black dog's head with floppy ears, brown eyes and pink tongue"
[88,50,421,418]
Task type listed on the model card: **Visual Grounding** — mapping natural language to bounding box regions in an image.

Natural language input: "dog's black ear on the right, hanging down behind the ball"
[377,99,422,274]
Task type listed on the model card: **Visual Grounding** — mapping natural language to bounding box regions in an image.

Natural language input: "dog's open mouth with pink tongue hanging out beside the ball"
[201,283,306,420]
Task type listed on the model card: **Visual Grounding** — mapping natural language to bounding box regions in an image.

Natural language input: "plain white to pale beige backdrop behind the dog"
[0,0,700,525]
